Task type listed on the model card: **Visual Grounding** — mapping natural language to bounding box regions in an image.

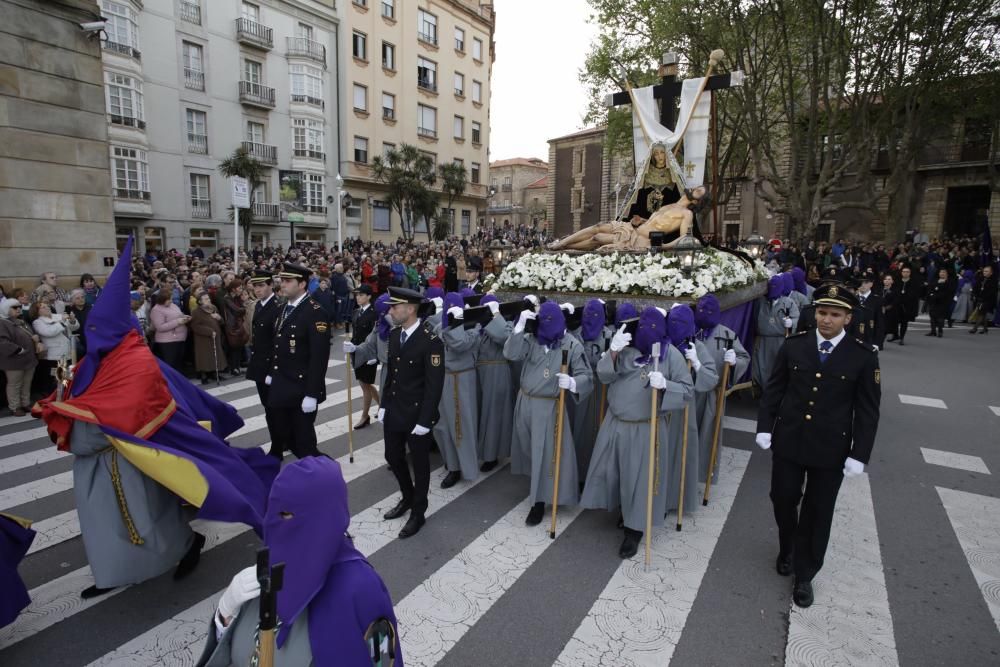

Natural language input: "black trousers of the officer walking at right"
[771,456,844,581]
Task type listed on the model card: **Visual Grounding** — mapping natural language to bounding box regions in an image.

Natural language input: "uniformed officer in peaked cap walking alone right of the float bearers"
[757,284,881,607]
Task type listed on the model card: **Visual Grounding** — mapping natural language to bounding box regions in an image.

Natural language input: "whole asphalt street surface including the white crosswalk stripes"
[0,321,1000,667]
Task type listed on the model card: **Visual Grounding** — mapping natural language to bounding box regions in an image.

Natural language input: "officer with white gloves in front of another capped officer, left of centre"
[264,262,330,459]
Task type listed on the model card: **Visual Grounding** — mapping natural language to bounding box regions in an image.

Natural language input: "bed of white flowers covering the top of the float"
[492,248,768,298]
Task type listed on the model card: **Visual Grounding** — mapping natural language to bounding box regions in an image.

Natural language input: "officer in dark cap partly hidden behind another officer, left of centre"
[247,269,284,460]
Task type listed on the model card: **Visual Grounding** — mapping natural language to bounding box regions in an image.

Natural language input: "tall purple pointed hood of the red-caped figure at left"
[70,236,135,396]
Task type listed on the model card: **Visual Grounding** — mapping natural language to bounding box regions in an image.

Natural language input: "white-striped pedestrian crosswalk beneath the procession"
[0,361,1000,667]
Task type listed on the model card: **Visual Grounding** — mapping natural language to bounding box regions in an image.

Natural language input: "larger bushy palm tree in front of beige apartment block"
[372,144,437,241]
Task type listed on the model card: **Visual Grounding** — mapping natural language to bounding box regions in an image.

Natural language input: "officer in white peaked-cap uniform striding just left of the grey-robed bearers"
[370,287,444,539]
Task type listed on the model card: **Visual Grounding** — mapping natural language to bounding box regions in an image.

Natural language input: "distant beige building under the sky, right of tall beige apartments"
[487,158,549,227]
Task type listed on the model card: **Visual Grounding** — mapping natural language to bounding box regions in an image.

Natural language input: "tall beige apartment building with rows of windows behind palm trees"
[340,0,495,240]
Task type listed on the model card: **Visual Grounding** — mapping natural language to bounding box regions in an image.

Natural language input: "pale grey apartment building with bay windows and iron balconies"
[100,0,339,251]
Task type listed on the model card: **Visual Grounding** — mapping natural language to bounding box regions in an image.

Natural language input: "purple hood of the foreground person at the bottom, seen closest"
[264,456,364,648]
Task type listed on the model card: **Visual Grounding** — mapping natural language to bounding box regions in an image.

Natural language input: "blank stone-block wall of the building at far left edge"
[0,0,117,289]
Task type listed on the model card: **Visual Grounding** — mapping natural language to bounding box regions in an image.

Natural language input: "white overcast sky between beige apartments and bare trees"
[490,0,597,161]
